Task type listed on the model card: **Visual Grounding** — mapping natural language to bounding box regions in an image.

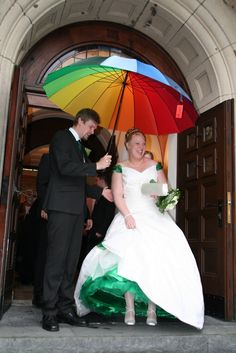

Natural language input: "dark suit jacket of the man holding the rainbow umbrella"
[43,130,99,215]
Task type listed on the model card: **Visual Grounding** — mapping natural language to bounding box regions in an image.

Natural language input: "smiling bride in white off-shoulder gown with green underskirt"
[75,129,204,329]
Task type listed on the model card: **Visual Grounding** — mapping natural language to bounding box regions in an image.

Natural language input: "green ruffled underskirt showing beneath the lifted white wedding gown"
[80,266,174,318]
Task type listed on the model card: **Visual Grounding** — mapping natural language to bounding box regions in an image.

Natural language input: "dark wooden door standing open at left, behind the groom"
[0,68,27,317]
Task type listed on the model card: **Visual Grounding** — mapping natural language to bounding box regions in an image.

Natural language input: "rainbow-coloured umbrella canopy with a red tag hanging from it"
[43,56,198,135]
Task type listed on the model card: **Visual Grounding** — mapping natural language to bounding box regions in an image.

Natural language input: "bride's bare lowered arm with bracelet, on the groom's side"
[111,172,136,228]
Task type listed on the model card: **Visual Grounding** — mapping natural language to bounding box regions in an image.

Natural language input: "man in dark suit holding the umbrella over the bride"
[42,108,111,331]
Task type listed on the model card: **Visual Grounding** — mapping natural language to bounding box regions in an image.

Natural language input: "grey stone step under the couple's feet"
[0,302,236,353]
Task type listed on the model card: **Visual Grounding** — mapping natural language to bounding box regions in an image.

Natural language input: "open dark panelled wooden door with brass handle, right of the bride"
[177,100,235,320]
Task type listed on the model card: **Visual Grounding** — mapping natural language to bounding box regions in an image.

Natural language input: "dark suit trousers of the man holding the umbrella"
[43,211,84,315]
